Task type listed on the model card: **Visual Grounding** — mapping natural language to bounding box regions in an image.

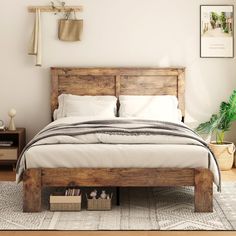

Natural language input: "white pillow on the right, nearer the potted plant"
[119,95,181,122]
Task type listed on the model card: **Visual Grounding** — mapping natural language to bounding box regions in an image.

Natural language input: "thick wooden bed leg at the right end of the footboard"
[194,169,213,212]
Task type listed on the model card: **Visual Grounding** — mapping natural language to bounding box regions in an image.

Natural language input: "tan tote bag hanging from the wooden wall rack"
[58,11,83,42]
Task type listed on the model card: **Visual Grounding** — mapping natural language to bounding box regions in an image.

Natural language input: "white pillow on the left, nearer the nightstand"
[54,94,117,119]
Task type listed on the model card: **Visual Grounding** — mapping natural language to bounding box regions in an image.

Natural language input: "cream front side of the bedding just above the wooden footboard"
[25,144,208,168]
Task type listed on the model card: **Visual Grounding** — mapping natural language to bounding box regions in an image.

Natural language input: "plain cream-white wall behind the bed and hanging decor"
[0,0,236,141]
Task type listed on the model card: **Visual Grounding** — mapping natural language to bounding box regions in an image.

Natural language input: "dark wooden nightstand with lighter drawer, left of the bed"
[0,128,25,168]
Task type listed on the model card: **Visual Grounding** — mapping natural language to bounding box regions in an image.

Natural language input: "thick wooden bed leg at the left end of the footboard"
[23,169,42,212]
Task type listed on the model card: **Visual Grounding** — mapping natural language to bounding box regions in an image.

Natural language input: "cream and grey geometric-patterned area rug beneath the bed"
[0,182,236,230]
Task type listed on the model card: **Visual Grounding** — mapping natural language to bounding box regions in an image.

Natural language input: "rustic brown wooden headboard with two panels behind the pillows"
[51,67,185,116]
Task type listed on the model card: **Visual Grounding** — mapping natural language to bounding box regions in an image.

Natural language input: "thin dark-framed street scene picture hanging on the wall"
[200,5,234,58]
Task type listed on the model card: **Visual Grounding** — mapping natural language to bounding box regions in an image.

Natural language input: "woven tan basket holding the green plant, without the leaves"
[208,142,235,170]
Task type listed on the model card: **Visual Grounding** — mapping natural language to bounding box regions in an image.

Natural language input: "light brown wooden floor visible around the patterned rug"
[0,167,236,236]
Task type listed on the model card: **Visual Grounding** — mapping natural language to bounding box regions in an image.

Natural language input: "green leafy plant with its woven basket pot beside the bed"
[196,90,236,170]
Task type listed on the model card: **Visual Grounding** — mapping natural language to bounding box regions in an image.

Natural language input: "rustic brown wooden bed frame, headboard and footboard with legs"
[23,68,213,212]
